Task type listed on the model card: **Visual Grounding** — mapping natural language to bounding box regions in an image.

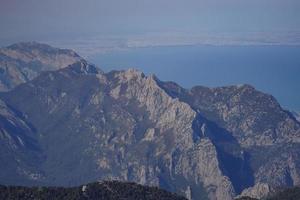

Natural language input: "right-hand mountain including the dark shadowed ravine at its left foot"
[160,82,300,198]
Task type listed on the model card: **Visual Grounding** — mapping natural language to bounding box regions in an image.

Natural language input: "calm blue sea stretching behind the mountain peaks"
[89,45,300,111]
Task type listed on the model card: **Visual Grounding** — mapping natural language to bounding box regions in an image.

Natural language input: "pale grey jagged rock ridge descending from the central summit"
[109,69,235,200]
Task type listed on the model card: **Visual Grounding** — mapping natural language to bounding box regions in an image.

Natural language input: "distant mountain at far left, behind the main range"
[0,42,82,91]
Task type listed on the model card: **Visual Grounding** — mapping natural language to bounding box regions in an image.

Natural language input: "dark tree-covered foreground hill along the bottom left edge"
[0,181,185,200]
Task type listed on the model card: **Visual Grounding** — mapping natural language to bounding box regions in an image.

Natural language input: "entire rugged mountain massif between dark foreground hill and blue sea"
[0,43,300,200]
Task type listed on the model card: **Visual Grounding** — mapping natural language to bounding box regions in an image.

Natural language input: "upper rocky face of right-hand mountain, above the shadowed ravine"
[162,83,300,147]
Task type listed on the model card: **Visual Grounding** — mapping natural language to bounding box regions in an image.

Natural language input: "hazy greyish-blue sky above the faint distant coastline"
[0,0,300,43]
